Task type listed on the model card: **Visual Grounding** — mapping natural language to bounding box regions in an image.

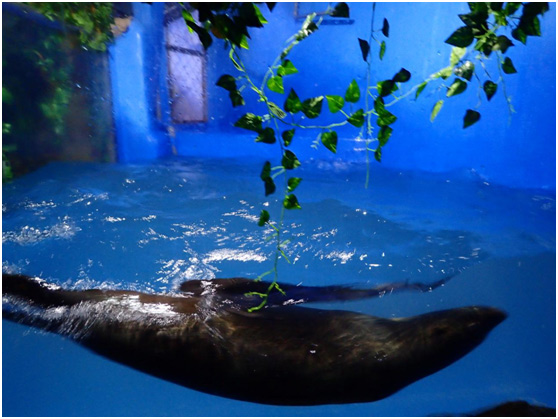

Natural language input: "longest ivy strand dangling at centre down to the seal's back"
[213,3,354,311]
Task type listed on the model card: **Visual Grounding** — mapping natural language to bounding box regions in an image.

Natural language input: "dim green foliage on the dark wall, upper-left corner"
[2,2,119,180]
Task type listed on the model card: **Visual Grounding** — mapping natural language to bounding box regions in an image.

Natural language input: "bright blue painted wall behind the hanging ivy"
[111,3,556,190]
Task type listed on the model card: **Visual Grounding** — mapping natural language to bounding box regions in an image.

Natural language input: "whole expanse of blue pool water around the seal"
[2,160,556,416]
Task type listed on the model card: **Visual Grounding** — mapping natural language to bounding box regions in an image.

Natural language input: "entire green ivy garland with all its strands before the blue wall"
[183,3,548,311]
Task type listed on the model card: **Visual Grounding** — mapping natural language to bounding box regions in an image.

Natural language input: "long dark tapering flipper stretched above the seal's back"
[180,275,453,307]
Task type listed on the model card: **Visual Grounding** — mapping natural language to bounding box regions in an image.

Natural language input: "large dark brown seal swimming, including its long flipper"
[2,273,506,405]
